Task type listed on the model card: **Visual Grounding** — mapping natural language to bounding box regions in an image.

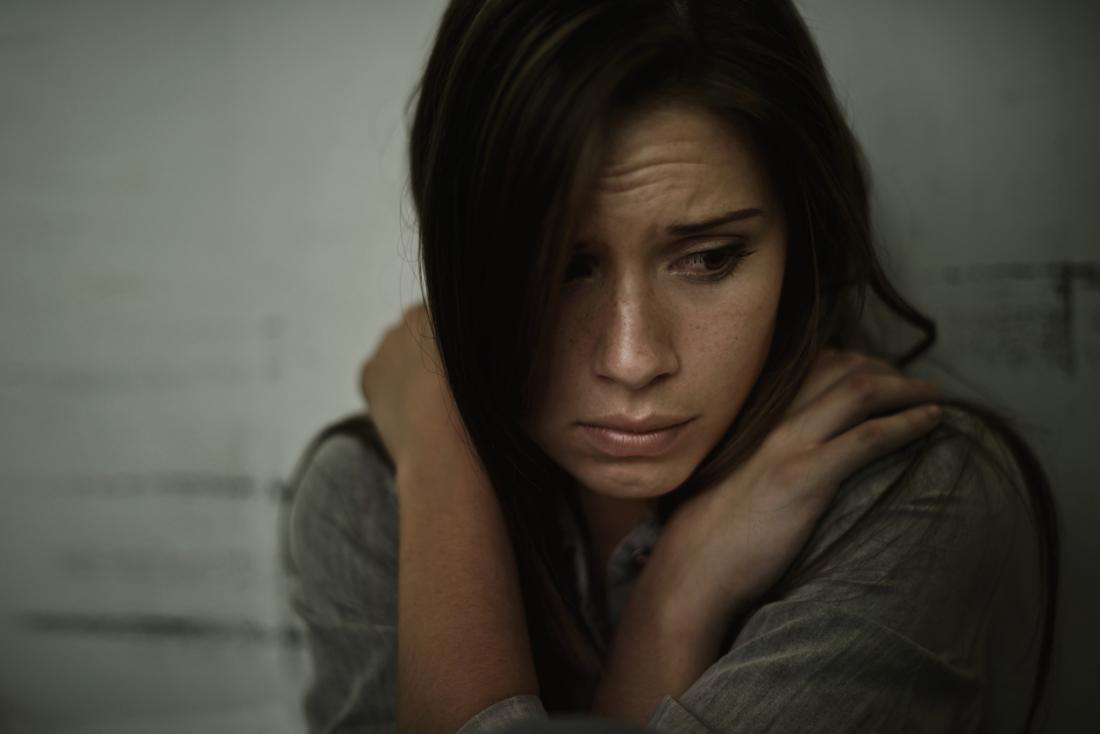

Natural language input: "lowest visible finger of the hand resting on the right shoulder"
[818,405,943,484]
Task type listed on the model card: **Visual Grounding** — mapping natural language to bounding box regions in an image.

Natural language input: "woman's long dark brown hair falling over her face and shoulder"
[410,0,1057,715]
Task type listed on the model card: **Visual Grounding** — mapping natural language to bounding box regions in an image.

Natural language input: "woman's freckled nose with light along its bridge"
[594,278,680,390]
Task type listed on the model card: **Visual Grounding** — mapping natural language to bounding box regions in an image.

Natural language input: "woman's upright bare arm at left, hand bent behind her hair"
[361,307,545,733]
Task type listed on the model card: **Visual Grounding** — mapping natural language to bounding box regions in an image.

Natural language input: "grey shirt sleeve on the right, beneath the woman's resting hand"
[649,407,1041,734]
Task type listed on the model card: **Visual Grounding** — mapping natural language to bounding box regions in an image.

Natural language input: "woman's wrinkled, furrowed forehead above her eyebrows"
[585,102,770,223]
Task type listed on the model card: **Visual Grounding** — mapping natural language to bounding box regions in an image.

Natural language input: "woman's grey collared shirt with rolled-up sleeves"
[288,408,1042,734]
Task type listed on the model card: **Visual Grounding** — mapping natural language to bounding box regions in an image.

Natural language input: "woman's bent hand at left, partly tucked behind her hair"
[360,304,465,468]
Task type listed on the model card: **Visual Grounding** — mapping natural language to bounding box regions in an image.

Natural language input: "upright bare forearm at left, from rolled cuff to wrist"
[397,431,538,733]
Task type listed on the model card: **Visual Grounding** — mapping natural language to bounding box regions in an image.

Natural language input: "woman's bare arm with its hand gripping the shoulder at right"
[594,352,938,724]
